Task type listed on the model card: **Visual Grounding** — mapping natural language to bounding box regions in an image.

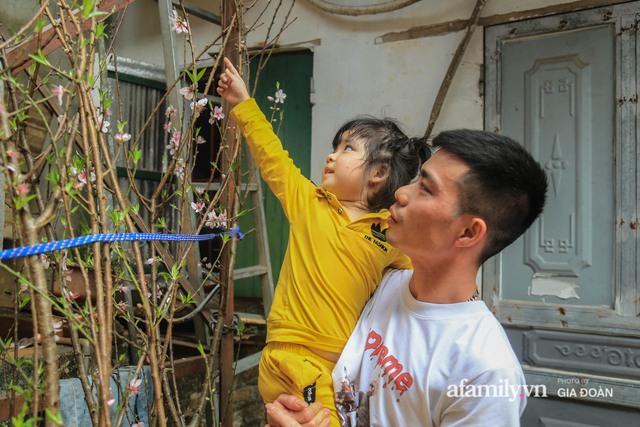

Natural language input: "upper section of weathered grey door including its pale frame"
[483,2,640,337]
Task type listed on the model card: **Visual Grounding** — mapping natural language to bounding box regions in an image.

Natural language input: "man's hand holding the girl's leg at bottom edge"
[266,394,331,427]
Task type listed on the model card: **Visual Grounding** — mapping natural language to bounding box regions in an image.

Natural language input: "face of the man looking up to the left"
[387,150,469,264]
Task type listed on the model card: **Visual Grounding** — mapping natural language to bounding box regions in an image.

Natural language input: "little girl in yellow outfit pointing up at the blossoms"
[217,58,430,425]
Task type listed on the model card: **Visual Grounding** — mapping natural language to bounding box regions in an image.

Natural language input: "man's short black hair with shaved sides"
[433,129,548,264]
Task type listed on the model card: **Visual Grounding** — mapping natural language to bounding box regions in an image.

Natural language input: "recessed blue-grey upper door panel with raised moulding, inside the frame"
[502,24,615,308]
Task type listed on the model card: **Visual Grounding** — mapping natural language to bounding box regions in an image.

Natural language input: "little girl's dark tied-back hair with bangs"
[332,116,431,212]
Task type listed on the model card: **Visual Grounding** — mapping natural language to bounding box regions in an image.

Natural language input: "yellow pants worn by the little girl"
[258,342,340,427]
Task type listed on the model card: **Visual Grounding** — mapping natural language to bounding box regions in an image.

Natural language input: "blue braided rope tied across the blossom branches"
[0,227,244,260]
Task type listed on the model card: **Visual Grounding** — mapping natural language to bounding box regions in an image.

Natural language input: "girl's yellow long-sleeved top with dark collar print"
[231,99,411,353]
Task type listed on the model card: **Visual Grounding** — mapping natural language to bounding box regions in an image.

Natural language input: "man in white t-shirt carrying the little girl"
[268,130,547,427]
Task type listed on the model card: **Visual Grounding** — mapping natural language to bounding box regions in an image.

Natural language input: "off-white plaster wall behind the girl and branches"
[117,0,570,182]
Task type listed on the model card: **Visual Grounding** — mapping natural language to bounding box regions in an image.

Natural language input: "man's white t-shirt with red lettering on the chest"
[333,270,528,427]
